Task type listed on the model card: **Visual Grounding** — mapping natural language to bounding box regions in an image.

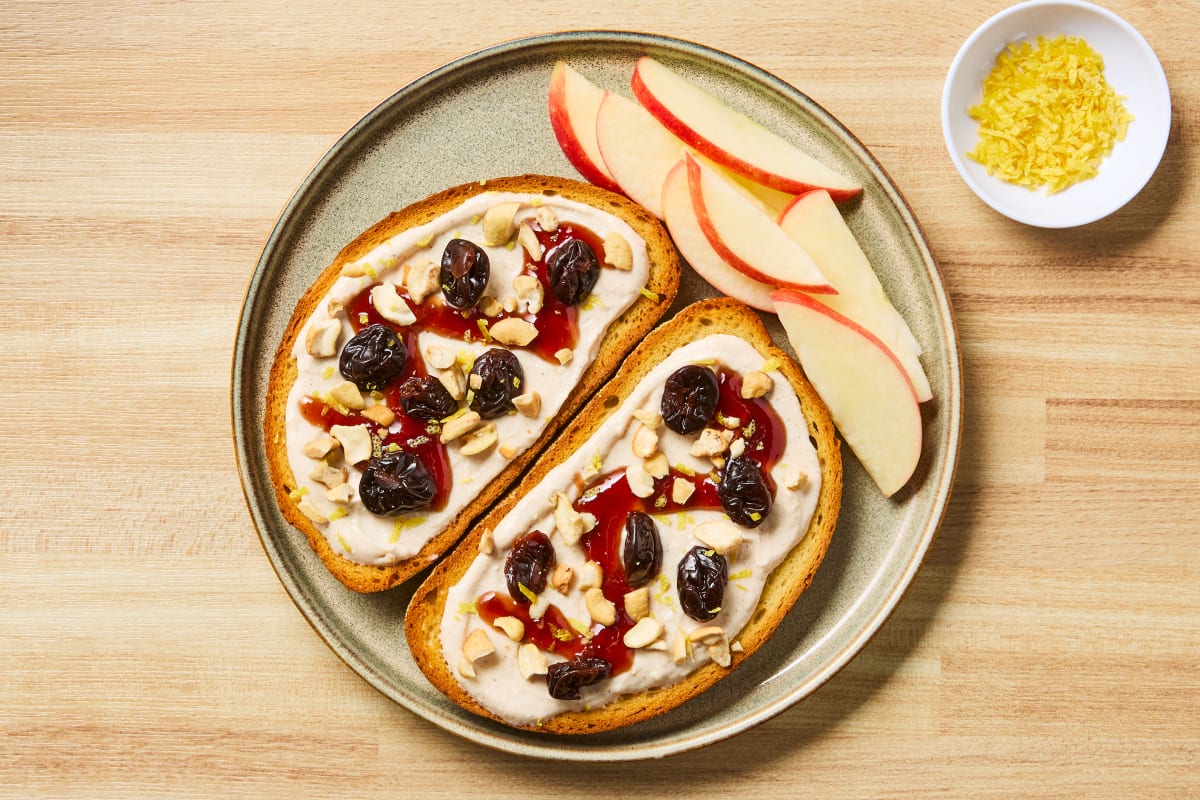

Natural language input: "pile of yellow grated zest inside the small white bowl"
[967,36,1133,194]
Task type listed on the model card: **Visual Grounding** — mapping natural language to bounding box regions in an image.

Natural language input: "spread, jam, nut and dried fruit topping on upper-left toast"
[286,191,649,564]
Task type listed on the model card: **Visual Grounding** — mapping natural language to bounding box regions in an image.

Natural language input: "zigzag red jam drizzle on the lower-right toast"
[475,368,786,675]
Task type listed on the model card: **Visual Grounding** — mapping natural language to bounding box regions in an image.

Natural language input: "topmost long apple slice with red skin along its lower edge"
[632,56,863,200]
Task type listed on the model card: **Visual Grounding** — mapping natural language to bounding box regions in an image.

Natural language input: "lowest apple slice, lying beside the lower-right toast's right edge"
[772,290,922,497]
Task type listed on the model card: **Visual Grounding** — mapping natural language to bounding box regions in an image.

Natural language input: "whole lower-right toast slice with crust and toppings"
[406,299,841,734]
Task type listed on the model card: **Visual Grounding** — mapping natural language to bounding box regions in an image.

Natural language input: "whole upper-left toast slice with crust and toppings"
[264,175,679,593]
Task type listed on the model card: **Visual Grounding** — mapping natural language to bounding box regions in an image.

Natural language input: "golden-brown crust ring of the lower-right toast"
[404,299,842,734]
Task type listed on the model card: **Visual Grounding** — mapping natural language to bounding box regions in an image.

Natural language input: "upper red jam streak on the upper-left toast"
[347,219,604,362]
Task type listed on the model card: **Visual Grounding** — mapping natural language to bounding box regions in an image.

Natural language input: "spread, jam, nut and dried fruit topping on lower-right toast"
[442,337,820,722]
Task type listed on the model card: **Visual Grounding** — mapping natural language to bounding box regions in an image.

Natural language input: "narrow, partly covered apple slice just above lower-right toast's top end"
[662,161,775,313]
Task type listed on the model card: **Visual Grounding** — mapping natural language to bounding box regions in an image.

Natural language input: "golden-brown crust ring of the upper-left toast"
[263,175,679,593]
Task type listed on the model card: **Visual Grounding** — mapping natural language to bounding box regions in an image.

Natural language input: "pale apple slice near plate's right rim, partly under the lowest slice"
[779,190,934,403]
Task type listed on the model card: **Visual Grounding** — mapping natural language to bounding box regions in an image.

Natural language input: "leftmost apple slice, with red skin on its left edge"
[550,61,620,192]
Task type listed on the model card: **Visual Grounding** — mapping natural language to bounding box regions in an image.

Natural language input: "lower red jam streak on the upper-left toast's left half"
[300,327,454,511]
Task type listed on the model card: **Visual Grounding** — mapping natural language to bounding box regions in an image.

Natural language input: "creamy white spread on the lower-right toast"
[442,335,821,724]
